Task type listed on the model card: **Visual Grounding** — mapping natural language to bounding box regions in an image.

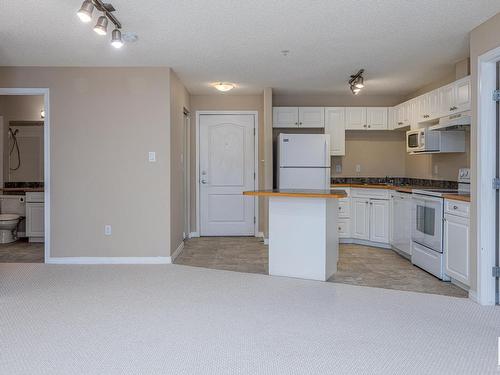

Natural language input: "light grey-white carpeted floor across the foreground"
[0,264,500,375]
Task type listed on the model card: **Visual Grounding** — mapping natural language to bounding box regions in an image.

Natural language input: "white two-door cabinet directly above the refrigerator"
[273,107,325,128]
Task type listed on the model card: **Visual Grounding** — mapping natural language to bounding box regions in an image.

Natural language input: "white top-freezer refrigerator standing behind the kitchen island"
[278,133,330,189]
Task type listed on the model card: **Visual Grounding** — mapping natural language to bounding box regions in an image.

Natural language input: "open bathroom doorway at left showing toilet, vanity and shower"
[0,89,50,263]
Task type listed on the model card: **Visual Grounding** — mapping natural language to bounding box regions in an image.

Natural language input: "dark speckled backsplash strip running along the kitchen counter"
[331,177,458,189]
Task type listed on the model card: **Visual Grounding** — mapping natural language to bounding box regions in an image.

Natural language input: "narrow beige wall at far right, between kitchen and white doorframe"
[470,13,500,290]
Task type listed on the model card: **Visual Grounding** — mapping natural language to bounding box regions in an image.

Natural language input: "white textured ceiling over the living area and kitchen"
[0,0,500,95]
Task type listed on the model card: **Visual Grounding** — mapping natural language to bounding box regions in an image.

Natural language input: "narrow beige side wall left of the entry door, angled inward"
[170,70,190,253]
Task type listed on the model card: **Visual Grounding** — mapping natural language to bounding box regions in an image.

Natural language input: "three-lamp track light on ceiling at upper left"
[77,0,128,48]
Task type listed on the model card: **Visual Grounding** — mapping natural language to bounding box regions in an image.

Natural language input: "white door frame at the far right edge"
[470,47,500,305]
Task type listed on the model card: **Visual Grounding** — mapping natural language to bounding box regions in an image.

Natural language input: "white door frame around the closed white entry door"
[191,111,259,237]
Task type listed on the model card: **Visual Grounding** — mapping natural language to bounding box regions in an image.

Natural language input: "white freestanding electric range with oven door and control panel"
[411,168,470,281]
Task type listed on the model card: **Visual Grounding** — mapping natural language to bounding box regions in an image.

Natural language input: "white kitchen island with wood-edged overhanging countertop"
[243,189,347,281]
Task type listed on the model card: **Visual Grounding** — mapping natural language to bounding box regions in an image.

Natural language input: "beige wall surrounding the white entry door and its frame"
[191,94,266,232]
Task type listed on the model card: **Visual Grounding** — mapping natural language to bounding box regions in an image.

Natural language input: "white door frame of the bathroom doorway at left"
[0,88,51,263]
